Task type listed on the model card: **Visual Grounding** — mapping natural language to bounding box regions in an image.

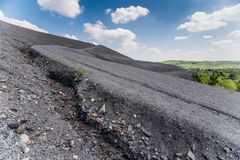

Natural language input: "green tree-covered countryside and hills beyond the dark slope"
[164,61,240,91]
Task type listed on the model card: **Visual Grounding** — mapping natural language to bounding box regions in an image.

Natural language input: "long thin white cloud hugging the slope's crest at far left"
[0,10,48,33]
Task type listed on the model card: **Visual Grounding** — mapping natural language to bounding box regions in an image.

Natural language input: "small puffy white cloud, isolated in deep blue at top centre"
[111,6,150,24]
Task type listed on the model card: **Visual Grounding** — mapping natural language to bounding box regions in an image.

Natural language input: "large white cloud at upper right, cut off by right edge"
[177,3,240,32]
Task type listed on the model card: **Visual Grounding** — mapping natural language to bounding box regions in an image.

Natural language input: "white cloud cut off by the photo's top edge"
[37,0,82,18]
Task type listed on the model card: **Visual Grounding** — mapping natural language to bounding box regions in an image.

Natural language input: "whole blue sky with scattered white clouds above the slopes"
[0,0,240,61]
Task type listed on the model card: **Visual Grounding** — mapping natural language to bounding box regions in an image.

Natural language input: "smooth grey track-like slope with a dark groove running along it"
[32,46,240,146]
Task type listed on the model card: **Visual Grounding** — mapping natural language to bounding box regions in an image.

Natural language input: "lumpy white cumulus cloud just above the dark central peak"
[84,21,138,48]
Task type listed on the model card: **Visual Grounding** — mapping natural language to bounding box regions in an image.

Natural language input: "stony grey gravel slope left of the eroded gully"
[0,23,125,160]
